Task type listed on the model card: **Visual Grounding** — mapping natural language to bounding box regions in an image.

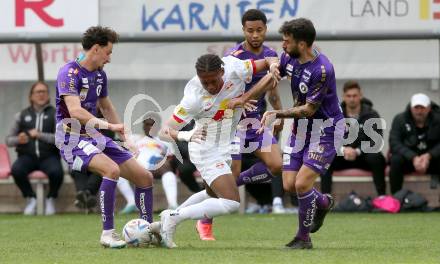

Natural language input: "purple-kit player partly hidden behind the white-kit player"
[196,9,283,240]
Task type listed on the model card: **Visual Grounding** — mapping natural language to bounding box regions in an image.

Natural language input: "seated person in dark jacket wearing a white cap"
[390,93,440,194]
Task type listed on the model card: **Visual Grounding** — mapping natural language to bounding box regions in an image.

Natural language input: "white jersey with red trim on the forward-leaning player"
[173,56,255,162]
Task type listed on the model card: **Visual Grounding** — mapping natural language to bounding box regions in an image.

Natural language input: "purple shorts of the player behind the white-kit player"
[231,129,278,160]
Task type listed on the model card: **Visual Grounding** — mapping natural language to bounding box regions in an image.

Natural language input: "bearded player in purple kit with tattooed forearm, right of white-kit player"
[259,18,345,249]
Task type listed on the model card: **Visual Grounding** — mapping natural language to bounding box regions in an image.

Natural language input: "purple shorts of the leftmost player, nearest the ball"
[60,135,133,172]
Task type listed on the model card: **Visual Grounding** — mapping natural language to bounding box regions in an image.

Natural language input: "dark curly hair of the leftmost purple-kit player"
[81,26,119,50]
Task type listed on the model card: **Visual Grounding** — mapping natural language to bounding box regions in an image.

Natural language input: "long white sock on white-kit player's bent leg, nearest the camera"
[177,198,240,221]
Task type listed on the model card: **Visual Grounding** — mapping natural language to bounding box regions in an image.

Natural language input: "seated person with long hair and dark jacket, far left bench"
[6,82,64,215]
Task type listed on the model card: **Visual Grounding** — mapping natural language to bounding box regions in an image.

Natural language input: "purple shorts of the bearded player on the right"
[283,136,336,174]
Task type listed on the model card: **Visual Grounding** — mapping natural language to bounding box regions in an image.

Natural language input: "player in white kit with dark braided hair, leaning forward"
[156,54,277,248]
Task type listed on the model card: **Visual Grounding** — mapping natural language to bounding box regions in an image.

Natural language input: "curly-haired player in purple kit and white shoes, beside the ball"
[56,26,153,248]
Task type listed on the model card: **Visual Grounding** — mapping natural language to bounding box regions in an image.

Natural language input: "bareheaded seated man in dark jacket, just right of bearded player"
[321,81,386,195]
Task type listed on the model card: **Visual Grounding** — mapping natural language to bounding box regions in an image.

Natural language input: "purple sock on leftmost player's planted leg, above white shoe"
[99,177,118,230]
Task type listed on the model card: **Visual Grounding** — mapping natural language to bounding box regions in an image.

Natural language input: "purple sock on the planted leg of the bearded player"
[296,189,317,241]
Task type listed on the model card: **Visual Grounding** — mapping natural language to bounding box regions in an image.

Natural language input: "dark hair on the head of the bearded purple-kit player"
[278,18,316,47]
